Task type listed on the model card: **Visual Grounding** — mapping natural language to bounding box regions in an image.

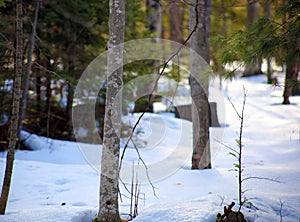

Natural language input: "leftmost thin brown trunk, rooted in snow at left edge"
[0,0,23,214]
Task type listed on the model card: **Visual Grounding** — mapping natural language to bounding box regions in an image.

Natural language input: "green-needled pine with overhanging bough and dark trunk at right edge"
[218,0,300,104]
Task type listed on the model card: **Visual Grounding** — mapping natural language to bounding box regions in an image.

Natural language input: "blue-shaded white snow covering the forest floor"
[0,75,300,222]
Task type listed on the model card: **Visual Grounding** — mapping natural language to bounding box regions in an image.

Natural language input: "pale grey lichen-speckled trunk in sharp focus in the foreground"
[97,0,125,222]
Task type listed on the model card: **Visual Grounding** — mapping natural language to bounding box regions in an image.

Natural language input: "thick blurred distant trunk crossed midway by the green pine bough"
[243,0,262,76]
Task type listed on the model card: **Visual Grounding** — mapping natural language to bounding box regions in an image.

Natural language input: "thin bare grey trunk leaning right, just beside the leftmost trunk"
[19,0,41,133]
